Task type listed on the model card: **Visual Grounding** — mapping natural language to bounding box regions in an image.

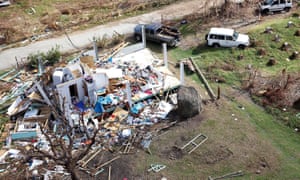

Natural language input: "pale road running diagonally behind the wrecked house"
[0,0,222,70]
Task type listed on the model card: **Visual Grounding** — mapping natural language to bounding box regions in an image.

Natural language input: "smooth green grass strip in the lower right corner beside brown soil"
[241,100,300,179]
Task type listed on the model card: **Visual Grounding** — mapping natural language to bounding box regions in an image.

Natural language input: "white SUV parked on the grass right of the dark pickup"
[206,28,250,49]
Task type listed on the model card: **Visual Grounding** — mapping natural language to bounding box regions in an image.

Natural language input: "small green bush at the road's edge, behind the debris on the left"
[27,46,61,68]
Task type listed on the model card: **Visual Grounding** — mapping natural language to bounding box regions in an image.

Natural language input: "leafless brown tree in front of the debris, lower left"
[29,104,98,180]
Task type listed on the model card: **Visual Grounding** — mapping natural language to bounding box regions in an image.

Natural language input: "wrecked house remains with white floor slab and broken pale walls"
[52,46,180,126]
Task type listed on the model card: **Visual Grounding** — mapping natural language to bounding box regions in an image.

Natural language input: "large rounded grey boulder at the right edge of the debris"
[177,86,202,118]
